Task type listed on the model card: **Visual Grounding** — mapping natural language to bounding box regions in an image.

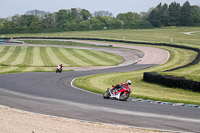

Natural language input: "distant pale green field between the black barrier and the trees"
[0,27,200,47]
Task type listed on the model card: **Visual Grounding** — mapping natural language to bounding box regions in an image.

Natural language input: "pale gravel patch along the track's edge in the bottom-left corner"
[0,105,166,133]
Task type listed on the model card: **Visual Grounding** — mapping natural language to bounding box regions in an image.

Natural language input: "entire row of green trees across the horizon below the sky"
[0,1,200,34]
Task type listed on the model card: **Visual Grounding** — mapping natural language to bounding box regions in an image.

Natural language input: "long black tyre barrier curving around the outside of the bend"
[0,37,200,92]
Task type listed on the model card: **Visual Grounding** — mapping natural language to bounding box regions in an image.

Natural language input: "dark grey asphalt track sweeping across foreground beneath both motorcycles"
[0,41,200,132]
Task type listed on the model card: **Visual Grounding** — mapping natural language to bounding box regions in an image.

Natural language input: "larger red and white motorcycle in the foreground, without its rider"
[103,86,131,101]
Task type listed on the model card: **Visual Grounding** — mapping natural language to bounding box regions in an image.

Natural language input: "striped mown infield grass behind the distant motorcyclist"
[0,45,123,73]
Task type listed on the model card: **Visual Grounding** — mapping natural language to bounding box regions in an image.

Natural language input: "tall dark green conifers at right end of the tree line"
[148,1,200,27]
